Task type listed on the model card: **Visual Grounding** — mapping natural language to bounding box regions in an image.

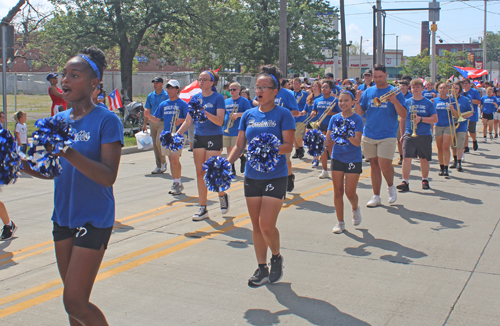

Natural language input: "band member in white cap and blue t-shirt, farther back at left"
[144,79,188,195]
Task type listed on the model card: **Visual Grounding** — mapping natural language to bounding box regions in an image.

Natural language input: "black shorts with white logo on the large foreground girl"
[52,222,113,250]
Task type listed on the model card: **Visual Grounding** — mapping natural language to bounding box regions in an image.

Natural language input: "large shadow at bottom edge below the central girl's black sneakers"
[244,283,369,326]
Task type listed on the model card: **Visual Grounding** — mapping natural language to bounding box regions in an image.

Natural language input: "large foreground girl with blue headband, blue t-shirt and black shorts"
[23,47,123,326]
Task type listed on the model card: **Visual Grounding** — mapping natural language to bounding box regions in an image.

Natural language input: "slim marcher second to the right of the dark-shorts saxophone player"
[450,82,474,172]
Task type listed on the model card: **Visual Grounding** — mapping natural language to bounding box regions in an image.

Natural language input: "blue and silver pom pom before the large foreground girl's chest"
[28,116,75,177]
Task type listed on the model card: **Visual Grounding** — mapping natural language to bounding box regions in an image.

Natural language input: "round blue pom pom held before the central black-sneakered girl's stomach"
[247,133,281,172]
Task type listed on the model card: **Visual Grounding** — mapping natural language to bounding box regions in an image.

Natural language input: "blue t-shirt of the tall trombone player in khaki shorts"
[359,85,405,140]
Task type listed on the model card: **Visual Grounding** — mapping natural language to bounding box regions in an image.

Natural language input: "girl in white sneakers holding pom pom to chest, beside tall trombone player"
[325,87,363,233]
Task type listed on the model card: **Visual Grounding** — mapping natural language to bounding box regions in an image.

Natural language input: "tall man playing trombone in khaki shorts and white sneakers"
[356,64,406,207]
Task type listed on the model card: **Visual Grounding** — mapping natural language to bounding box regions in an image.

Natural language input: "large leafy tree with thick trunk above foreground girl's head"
[37,0,186,99]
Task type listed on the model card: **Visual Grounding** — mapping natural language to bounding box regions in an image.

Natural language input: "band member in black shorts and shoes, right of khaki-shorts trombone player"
[396,79,438,192]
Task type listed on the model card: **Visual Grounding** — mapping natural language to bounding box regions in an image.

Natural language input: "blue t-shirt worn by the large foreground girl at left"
[52,105,123,228]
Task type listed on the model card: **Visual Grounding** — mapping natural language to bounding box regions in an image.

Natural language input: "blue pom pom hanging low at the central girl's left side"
[203,156,234,192]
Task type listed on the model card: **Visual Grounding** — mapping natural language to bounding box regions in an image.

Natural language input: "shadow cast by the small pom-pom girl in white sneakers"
[344,229,427,264]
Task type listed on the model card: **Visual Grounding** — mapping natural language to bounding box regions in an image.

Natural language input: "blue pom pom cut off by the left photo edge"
[0,129,22,185]
